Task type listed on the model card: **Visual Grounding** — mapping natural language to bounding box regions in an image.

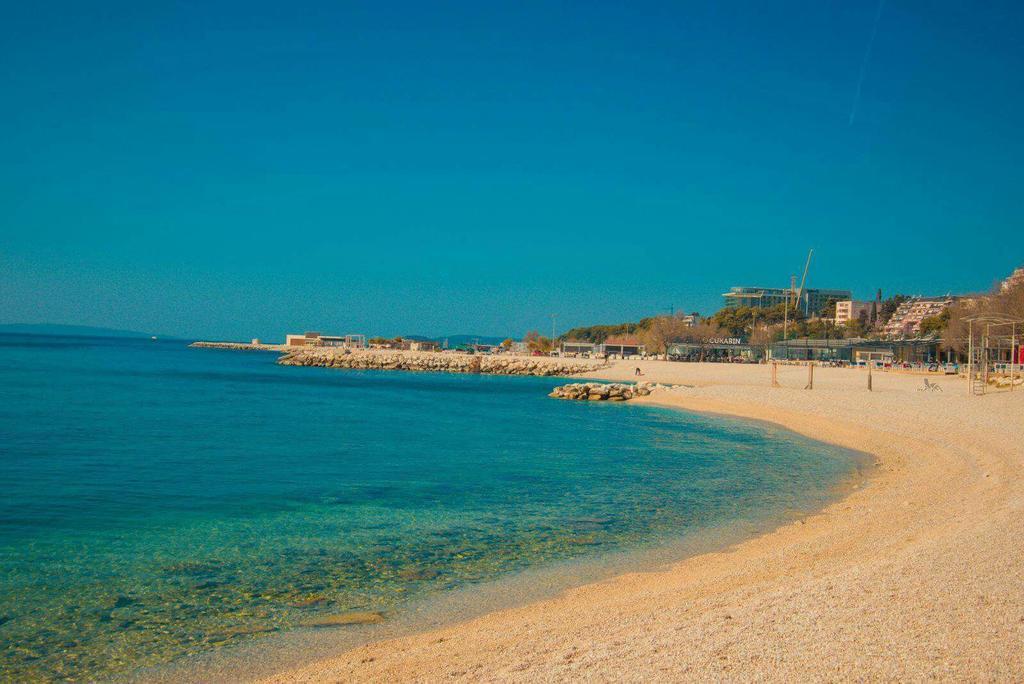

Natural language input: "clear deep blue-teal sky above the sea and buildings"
[0,0,1024,339]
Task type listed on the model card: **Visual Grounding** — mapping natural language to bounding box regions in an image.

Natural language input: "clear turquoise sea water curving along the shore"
[0,335,859,681]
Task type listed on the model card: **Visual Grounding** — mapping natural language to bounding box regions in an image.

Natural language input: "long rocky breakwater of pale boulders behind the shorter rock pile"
[278,349,602,376]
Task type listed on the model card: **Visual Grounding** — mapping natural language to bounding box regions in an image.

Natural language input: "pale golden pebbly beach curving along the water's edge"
[267,361,1024,684]
